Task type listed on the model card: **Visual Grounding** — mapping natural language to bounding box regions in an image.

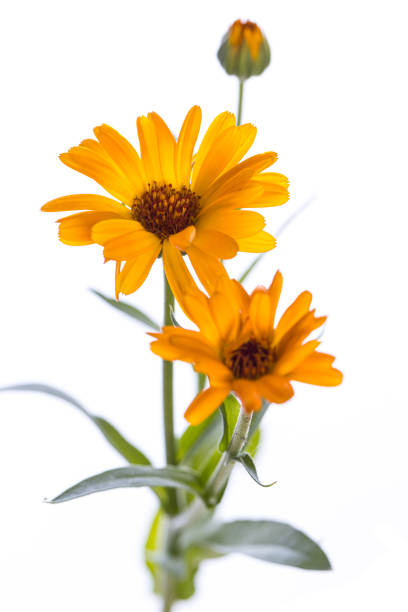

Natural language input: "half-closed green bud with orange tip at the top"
[217,19,271,80]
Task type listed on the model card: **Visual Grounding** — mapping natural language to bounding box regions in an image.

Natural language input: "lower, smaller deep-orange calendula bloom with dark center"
[151,272,342,425]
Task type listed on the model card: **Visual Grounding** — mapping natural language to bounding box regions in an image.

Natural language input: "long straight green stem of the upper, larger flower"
[163,275,178,514]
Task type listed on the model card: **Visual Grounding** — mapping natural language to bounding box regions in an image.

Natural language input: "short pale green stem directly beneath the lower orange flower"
[205,408,252,506]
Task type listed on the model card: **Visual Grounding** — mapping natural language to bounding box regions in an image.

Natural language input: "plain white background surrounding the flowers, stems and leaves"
[0,0,408,612]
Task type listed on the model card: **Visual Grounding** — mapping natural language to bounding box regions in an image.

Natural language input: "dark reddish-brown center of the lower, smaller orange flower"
[224,338,275,380]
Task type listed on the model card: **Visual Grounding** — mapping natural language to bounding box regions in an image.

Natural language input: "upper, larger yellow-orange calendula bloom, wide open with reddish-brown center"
[42,106,289,299]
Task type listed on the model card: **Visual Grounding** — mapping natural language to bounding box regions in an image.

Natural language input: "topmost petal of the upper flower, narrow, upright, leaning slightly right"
[176,106,201,187]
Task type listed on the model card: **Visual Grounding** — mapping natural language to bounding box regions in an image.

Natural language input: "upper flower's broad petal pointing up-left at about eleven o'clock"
[94,124,146,196]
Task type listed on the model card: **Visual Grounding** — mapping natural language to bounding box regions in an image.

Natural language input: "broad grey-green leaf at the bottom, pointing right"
[188,520,331,570]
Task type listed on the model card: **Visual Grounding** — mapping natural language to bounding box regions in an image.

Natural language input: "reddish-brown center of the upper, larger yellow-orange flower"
[132,181,200,240]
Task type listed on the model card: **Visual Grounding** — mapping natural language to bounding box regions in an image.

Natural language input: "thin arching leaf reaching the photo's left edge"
[0,383,151,465]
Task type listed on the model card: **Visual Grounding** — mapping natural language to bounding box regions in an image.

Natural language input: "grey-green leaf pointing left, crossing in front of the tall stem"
[47,465,202,504]
